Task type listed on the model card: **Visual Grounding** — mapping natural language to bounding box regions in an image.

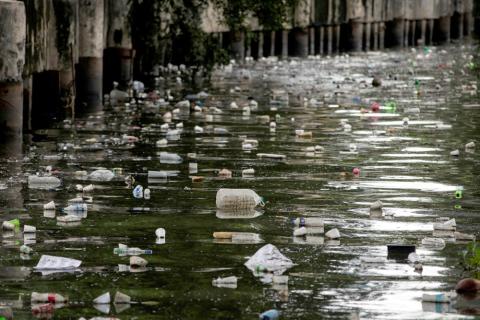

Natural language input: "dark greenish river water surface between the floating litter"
[0,44,480,319]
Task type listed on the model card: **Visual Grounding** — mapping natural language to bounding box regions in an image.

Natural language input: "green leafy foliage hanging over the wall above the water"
[130,0,299,79]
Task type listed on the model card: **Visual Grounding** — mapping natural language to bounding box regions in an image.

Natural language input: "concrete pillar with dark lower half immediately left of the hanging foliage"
[103,0,134,92]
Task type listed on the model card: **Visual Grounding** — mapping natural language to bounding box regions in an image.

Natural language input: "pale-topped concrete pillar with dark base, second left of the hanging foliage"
[76,0,104,110]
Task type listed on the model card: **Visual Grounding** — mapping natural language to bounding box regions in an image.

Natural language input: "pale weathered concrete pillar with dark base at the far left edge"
[0,1,26,144]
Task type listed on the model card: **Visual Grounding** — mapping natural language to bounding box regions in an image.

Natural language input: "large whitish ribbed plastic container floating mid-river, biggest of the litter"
[216,188,264,210]
